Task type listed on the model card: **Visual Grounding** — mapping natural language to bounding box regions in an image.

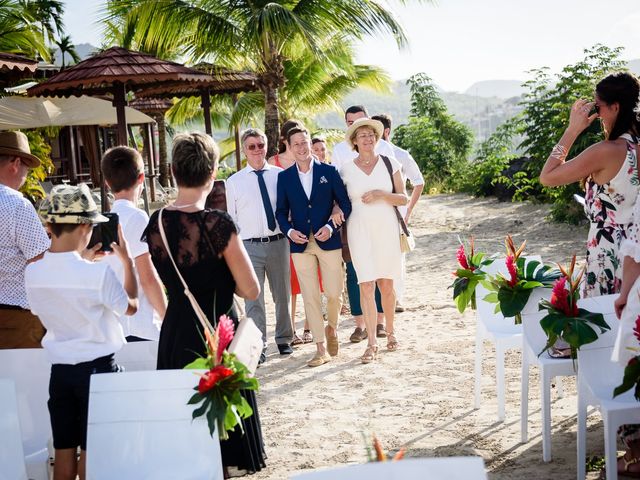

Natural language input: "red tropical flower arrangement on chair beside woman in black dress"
[184,315,258,440]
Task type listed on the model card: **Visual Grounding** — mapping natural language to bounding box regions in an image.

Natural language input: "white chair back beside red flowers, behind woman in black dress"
[87,370,223,480]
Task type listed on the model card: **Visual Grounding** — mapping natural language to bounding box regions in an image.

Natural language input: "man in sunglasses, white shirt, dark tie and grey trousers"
[226,128,293,363]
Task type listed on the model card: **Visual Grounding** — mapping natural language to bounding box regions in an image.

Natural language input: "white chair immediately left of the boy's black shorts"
[0,348,51,480]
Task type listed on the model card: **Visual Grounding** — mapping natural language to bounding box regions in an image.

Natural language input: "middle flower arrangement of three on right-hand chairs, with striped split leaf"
[481,235,560,325]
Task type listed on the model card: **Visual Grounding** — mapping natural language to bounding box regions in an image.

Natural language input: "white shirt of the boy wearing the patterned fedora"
[25,252,129,365]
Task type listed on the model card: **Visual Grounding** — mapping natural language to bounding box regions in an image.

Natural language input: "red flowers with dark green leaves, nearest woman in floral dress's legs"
[539,255,610,360]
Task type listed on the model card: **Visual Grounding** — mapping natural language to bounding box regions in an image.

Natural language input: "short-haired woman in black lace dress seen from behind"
[143,133,265,473]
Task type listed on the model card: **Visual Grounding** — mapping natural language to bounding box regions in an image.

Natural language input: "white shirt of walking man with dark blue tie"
[226,162,282,240]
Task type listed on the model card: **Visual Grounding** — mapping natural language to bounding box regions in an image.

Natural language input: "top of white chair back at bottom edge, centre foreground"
[289,457,487,480]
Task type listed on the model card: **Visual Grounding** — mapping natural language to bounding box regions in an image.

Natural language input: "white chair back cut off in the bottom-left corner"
[0,378,27,480]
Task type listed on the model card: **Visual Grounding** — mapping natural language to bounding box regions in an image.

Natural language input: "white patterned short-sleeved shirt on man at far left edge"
[0,184,51,308]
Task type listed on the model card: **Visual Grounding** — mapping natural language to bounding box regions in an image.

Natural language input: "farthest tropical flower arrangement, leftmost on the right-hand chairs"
[449,237,493,313]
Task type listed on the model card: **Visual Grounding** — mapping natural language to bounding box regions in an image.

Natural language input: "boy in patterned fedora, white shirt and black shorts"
[25,184,138,480]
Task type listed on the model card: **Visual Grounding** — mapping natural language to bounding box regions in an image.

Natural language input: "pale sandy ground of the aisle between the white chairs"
[252,195,616,480]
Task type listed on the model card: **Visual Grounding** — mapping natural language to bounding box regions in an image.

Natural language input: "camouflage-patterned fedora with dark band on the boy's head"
[43,183,109,224]
